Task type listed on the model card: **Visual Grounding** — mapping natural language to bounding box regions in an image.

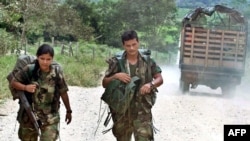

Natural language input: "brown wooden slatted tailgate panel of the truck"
[182,27,246,68]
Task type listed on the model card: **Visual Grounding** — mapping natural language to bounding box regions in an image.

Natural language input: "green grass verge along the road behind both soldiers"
[0,40,172,103]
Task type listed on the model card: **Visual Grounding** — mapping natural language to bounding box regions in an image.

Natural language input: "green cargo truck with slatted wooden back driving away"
[179,5,247,95]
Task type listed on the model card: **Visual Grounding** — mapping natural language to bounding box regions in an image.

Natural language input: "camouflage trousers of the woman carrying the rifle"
[18,114,59,141]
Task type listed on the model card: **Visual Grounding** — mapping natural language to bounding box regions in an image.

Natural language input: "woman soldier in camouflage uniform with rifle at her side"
[11,44,72,141]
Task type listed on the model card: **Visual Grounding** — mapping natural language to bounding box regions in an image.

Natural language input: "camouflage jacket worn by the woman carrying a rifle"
[13,64,68,119]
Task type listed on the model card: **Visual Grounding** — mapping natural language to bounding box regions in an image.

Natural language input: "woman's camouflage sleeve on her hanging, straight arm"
[57,66,69,94]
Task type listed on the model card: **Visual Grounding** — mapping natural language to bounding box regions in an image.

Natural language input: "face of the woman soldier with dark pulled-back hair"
[38,53,53,72]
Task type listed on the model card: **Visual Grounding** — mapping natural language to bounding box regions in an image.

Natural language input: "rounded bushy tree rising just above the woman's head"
[44,4,94,41]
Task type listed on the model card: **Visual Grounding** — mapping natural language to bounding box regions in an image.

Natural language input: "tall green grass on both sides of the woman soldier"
[0,44,107,99]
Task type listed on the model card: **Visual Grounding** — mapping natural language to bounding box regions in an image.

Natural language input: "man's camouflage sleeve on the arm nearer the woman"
[105,57,119,77]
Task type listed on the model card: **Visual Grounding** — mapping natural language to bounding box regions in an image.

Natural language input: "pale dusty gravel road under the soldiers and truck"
[0,66,250,141]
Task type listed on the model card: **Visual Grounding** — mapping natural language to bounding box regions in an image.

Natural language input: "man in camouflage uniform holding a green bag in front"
[102,30,163,141]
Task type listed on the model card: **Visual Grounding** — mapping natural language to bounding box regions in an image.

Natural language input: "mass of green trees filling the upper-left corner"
[0,0,94,45]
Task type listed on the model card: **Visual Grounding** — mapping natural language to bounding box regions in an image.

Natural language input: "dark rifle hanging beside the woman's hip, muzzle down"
[19,91,41,136]
